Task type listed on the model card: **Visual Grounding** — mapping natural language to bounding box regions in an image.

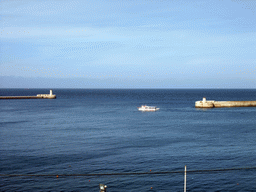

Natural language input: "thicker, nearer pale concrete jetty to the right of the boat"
[195,97,256,108]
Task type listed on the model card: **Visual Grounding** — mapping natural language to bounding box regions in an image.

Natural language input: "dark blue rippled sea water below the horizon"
[0,89,256,192]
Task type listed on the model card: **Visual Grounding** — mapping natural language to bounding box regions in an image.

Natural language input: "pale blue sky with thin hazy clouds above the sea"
[0,0,256,89]
